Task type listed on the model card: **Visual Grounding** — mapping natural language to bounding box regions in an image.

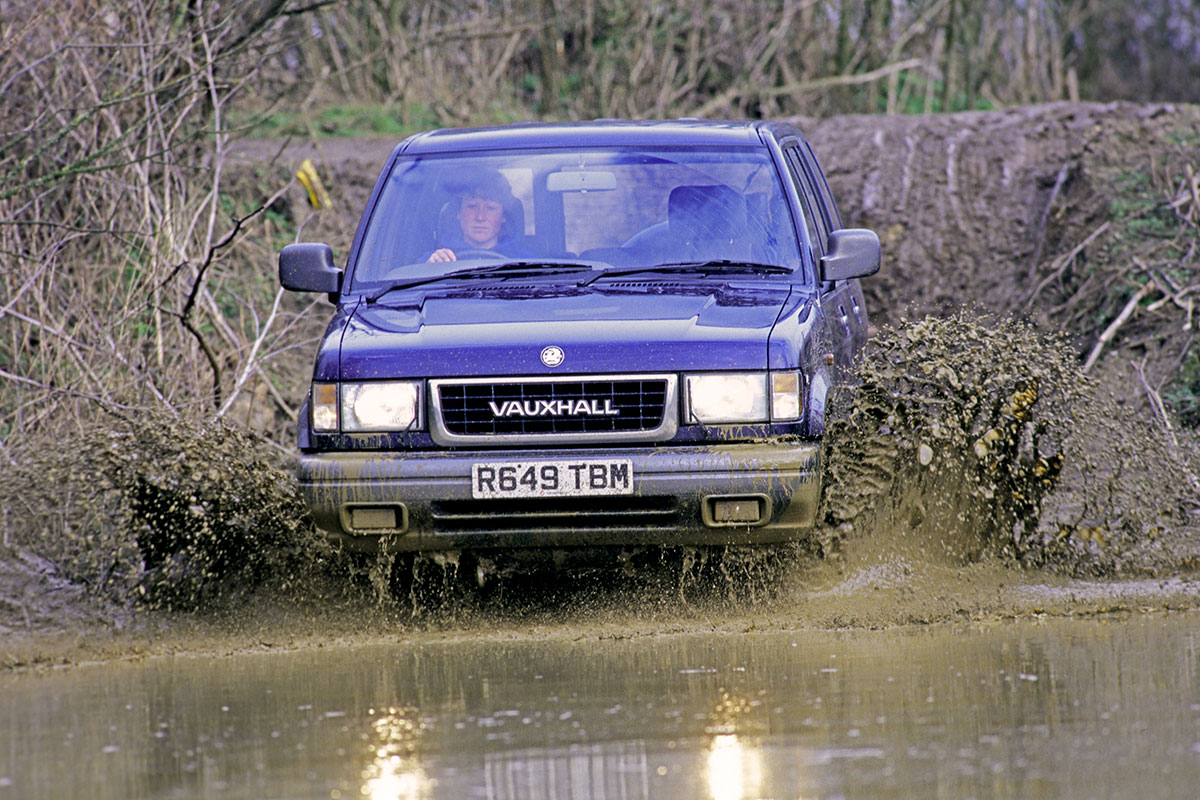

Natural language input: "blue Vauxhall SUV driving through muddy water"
[280,120,880,566]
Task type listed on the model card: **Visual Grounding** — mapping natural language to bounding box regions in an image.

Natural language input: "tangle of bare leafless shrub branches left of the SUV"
[0,0,309,444]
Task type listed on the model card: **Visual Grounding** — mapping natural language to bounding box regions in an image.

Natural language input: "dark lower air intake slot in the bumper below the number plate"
[432,497,682,534]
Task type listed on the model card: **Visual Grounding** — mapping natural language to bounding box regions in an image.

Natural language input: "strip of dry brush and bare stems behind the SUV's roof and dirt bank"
[260,0,1200,127]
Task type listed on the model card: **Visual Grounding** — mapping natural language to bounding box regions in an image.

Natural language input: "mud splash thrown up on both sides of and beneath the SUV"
[0,312,1200,657]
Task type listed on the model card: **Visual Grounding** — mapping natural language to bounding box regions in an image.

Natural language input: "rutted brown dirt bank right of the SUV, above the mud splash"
[802,103,1200,386]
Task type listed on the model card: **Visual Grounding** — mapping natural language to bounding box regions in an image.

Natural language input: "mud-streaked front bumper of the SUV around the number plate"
[299,439,821,552]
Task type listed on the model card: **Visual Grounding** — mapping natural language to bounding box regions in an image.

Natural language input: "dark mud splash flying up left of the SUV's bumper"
[0,416,331,609]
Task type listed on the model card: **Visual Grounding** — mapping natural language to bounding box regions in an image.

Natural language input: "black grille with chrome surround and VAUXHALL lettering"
[434,375,674,441]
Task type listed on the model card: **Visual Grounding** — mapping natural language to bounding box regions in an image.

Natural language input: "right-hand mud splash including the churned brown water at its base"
[784,312,1200,626]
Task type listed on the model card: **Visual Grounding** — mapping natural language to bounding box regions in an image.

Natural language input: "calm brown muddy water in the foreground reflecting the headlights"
[7,612,1200,800]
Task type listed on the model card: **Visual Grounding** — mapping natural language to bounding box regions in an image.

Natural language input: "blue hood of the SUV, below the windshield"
[325,281,791,380]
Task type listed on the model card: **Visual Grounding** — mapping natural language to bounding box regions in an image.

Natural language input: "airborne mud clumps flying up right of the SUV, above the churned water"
[823,311,1200,575]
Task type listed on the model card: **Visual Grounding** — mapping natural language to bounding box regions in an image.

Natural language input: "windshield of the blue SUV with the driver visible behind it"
[352,146,800,291]
